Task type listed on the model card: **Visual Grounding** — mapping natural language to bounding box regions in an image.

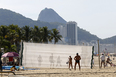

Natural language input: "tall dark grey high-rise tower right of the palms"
[66,21,77,45]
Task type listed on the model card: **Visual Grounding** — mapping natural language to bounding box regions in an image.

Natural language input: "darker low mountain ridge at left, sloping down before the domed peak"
[0,9,58,29]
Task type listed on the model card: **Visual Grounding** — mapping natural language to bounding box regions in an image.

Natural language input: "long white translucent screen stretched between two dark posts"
[22,42,92,68]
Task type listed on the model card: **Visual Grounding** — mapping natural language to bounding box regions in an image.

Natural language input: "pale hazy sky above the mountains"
[0,0,116,39]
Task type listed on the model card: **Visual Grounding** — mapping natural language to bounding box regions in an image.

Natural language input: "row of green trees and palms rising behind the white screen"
[0,24,62,52]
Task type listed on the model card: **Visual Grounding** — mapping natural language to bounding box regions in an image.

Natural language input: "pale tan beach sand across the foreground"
[1,57,116,77]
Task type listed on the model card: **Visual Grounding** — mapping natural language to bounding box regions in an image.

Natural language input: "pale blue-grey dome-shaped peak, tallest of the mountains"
[38,8,66,24]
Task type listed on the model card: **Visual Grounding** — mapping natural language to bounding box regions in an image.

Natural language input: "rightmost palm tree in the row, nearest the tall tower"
[49,29,62,44]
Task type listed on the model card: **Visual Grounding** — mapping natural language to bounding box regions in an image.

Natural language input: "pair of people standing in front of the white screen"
[68,53,81,70]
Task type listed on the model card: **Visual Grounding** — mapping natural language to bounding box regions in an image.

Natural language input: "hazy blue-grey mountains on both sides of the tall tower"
[0,8,116,43]
